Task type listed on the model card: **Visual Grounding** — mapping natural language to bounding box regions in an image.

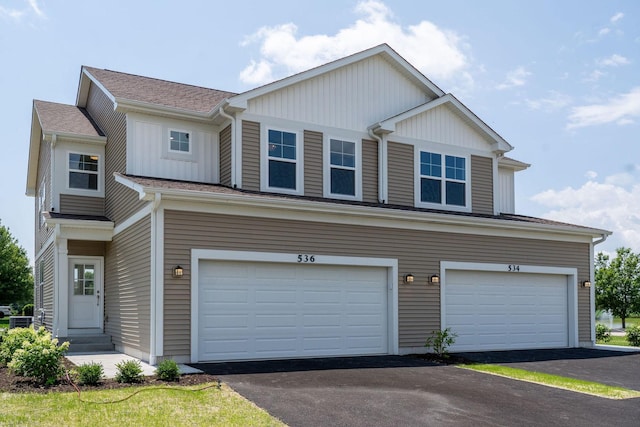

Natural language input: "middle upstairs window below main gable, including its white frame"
[323,136,362,200]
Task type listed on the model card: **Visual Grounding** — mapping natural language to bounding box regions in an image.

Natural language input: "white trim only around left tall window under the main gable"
[260,124,304,196]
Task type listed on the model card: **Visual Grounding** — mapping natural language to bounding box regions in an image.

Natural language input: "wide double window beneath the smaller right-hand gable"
[418,151,467,208]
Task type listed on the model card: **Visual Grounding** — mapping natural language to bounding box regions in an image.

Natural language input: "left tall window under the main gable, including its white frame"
[261,128,303,194]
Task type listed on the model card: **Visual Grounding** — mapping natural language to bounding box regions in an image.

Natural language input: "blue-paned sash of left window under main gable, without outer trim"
[267,129,298,191]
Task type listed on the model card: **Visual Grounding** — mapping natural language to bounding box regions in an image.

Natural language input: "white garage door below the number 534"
[444,271,569,351]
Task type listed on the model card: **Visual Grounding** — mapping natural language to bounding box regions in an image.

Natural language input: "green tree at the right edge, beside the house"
[595,248,640,328]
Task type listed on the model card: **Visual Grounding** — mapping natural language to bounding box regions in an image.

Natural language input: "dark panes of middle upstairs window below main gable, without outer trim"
[329,139,356,196]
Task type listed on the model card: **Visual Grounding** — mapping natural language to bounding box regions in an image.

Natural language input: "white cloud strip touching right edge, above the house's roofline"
[567,86,640,129]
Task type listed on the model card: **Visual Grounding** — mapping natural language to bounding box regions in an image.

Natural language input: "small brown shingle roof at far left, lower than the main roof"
[33,100,104,136]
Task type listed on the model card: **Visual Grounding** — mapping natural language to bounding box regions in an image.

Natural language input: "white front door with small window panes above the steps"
[69,258,102,329]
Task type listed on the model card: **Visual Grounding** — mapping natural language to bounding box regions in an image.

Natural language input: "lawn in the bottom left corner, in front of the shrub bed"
[0,384,285,427]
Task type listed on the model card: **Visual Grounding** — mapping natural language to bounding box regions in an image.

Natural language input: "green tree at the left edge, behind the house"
[0,223,33,306]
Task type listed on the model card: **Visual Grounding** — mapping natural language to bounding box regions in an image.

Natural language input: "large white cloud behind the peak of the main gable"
[240,0,470,85]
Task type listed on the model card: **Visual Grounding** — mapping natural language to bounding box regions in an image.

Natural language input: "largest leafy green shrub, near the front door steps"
[7,328,69,385]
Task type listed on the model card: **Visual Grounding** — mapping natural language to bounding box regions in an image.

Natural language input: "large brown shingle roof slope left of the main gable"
[83,66,236,113]
